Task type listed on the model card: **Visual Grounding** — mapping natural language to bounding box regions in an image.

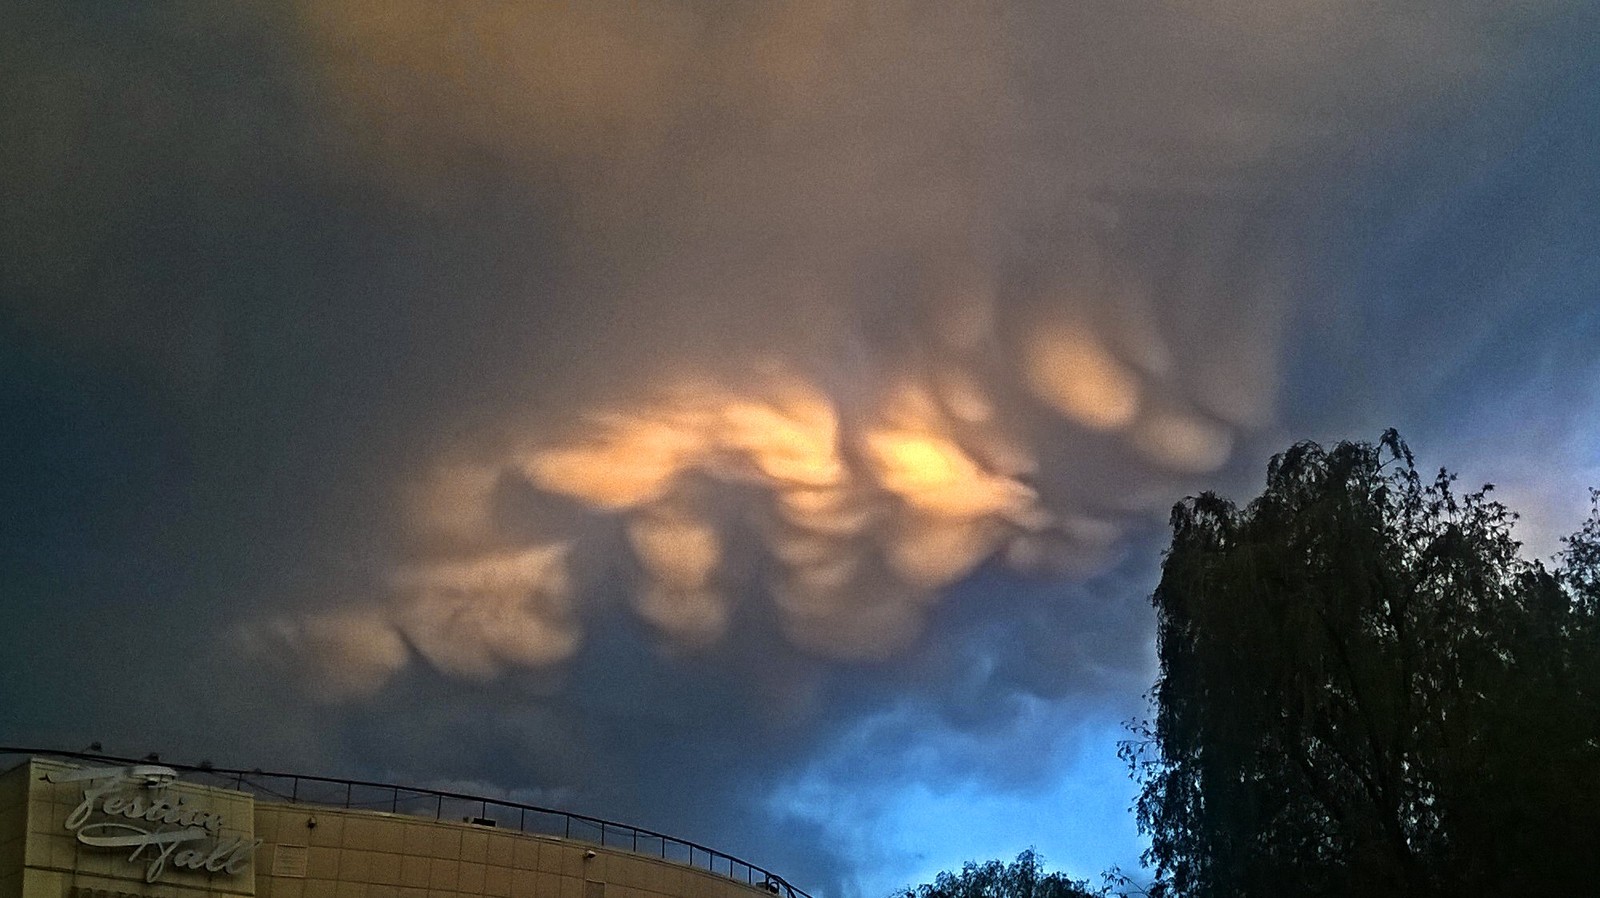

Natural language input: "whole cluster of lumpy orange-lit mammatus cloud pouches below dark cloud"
[253,318,1260,696]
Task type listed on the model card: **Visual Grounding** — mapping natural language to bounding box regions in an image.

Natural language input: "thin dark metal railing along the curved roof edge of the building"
[0,746,811,898]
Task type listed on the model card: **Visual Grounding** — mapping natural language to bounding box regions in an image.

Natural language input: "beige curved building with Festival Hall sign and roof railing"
[0,752,810,898]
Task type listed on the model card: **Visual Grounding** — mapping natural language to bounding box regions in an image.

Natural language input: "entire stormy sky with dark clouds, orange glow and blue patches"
[0,0,1600,898]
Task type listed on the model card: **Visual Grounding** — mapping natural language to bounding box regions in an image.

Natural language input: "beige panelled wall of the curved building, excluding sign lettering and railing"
[0,759,787,898]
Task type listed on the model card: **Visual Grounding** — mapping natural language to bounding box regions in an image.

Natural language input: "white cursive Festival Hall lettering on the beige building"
[45,767,261,882]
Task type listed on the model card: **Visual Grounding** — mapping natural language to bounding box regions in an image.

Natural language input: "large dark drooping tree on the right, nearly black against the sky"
[1125,431,1600,898]
